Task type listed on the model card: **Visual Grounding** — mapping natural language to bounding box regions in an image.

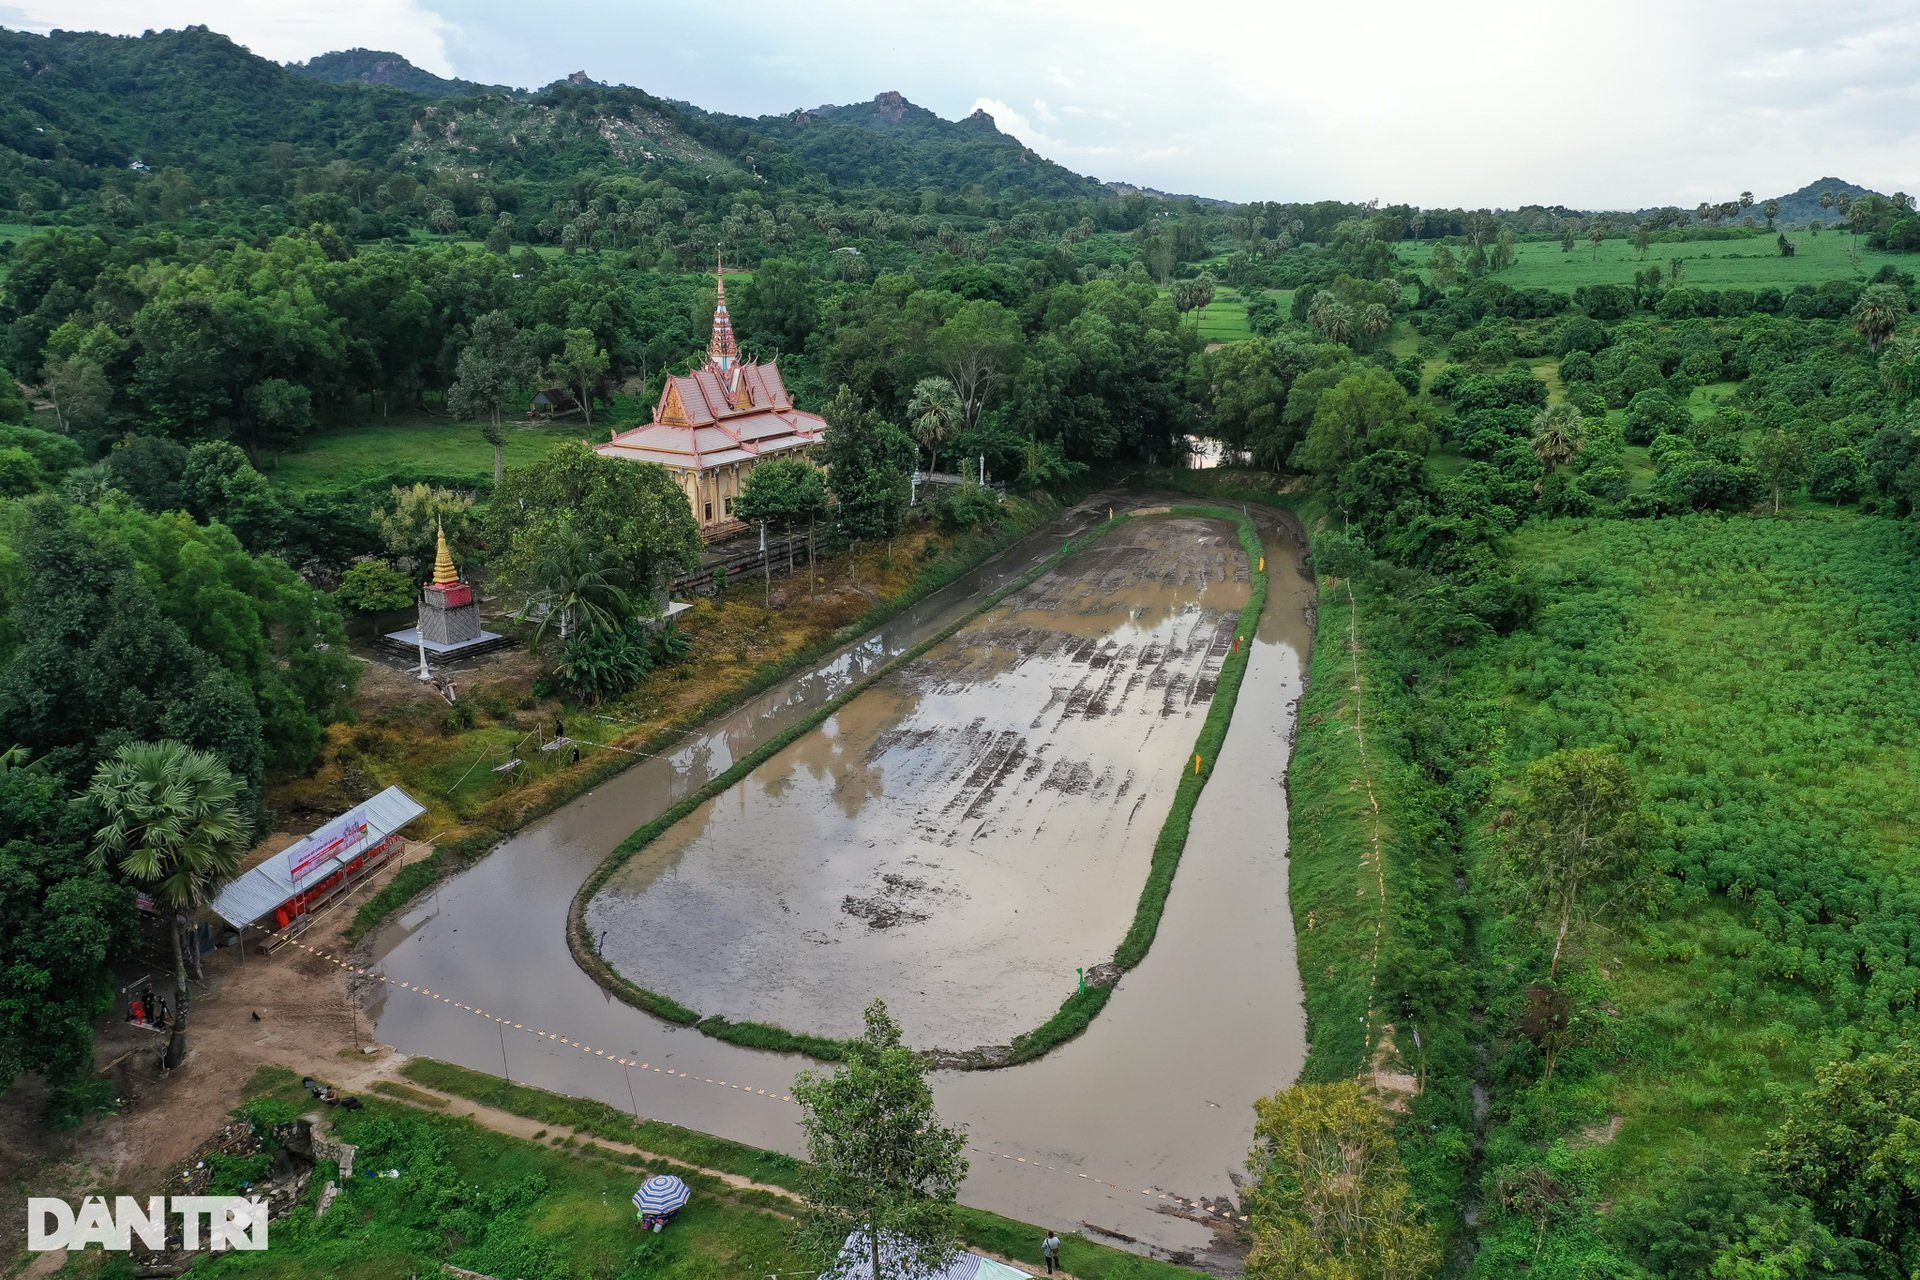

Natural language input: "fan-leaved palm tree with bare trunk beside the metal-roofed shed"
[86,741,253,1067]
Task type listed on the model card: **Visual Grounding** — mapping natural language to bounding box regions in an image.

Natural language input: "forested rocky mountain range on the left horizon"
[0,27,1110,209]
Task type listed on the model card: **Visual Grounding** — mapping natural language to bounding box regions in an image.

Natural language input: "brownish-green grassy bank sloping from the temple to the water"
[318,501,1058,942]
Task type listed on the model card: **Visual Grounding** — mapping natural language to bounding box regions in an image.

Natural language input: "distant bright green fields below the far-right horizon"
[1400,230,1920,292]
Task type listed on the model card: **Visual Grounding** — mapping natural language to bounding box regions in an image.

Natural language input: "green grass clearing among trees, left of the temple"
[261,418,609,497]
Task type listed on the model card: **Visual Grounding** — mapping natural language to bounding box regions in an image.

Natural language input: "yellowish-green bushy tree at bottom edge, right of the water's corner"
[1246,1080,1440,1280]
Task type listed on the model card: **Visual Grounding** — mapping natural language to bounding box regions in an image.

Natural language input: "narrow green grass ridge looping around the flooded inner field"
[566,505,1267,1067]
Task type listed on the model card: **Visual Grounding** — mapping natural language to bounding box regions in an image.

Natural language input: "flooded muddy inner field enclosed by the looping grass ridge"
[588,518,1248,1050]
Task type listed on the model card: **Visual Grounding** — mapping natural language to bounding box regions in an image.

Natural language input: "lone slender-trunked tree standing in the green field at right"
[1500,747,1649,983]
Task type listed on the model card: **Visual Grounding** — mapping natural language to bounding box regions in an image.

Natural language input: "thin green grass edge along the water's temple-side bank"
[346,505,1058,942]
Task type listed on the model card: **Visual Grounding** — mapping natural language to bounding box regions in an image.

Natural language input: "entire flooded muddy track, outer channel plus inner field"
[367,495,1313,1272]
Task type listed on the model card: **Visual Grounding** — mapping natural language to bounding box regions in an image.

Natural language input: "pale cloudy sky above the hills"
[0,0,1920,207]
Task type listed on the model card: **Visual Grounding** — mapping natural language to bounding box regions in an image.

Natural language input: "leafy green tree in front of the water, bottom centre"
[793,1000,968,1280]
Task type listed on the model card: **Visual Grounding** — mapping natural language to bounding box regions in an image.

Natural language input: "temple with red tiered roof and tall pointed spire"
[593,259,828,524]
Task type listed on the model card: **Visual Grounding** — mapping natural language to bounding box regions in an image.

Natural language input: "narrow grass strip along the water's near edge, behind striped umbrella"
[401,1057,1194,1280]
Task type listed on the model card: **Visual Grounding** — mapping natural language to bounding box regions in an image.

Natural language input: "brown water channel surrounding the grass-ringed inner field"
[371,495,1313,1270]
